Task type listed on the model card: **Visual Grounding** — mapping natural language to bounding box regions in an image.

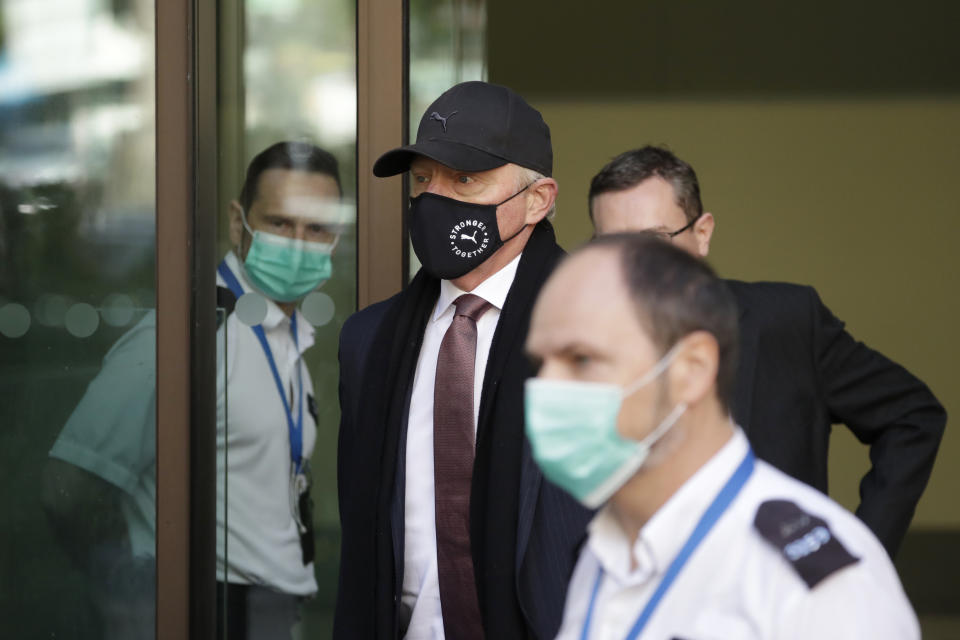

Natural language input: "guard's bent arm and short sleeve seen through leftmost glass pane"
[42,308,157,638]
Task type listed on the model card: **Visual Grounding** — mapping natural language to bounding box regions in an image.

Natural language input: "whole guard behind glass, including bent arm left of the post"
[44,142,342,640]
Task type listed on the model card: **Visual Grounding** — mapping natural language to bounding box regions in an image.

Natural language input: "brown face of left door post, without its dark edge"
[155,0,193,640]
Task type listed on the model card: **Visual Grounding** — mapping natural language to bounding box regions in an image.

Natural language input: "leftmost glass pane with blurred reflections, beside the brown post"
[0,0,156,638]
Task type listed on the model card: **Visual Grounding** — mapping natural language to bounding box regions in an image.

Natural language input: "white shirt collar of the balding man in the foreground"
[587,427,749,583]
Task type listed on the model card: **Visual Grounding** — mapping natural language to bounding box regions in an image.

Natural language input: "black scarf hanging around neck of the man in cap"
[350,220,563,638]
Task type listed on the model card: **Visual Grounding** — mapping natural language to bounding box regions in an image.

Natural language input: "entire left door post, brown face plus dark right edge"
[155,0,217,640]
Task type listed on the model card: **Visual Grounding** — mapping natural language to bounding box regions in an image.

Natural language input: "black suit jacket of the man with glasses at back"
[727,280,946,556]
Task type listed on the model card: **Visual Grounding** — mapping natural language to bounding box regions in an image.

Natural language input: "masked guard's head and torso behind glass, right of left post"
[217,142,352,640]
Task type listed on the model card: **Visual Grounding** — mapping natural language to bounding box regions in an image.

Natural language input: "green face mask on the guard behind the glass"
[243,213,339,302]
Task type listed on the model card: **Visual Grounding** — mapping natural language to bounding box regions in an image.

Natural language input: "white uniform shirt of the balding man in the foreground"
[557,429,920,640]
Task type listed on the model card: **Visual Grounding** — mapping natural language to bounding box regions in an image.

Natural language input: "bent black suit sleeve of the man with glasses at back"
[808,288,947,557]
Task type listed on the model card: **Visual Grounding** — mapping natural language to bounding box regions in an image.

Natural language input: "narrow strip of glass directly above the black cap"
[406,0,487,278]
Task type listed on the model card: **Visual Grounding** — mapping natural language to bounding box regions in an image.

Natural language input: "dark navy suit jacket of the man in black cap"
[334,239,592,639]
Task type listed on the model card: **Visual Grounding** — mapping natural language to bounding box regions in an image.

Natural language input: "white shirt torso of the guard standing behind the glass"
[217,251,317,596]
